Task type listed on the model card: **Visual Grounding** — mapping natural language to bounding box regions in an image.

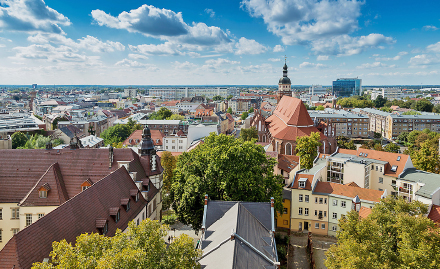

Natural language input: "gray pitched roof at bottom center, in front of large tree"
[199,201,277,268]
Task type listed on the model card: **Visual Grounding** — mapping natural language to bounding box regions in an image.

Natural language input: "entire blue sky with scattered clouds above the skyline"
[0,0,440,85]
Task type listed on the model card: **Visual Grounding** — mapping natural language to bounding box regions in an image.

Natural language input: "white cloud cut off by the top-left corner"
[0,0,70,34]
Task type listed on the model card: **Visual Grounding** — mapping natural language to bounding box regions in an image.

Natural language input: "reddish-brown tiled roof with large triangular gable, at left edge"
[0,148,163,206]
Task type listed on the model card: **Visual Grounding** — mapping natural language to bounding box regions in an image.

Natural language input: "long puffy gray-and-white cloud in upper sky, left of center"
[92,5,231,49]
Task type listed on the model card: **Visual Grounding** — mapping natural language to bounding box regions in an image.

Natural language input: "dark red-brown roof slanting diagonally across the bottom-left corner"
[0,167,147,269]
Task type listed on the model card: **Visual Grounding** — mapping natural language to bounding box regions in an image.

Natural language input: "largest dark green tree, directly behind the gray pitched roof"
[171,133,283,230]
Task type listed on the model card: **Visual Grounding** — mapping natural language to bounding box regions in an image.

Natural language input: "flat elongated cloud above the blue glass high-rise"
[312,34,395,56]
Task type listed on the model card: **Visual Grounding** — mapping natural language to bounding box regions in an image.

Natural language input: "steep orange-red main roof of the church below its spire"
[273,96,313,126]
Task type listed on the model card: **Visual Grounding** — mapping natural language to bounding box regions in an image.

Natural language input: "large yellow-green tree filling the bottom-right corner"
[325,197,440,269]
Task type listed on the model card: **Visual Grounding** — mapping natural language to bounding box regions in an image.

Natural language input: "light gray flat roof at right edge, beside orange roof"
[399,168,440,199]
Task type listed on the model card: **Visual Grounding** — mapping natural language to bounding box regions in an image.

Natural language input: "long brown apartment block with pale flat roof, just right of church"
[309,109,369,138]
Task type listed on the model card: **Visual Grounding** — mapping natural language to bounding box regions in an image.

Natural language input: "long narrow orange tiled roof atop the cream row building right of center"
[314,181,383,202]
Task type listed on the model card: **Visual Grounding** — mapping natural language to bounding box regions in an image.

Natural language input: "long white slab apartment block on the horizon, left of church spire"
[149,87,240,100]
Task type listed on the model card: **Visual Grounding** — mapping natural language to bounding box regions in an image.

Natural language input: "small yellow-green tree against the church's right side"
[296,132,321,169]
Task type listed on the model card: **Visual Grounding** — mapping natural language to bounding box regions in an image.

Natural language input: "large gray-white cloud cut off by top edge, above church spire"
[241,0,363,45]
